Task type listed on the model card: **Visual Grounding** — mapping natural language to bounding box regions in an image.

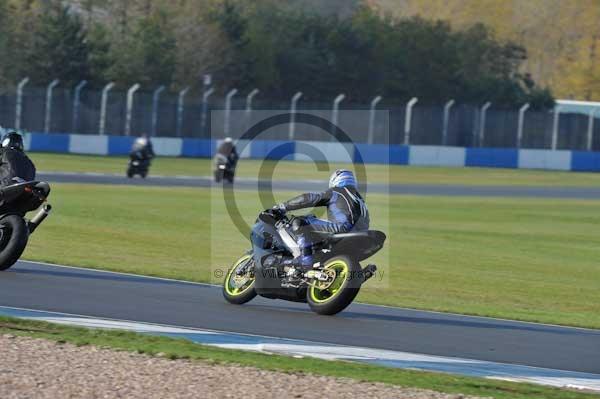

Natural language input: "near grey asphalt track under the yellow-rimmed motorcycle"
[0,261,600,373]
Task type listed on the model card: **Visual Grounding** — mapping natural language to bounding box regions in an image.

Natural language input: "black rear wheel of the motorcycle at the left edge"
[0,215,29,270]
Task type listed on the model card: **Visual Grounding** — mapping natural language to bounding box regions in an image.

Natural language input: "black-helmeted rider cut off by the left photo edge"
[0,131,36,187]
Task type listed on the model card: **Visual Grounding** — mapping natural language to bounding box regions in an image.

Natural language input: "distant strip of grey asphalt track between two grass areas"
[37,172,600,199]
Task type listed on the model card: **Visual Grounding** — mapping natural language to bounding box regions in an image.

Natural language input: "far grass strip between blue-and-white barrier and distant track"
[31,153,600,187]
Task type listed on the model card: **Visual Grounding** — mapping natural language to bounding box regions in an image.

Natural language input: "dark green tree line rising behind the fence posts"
[0,0,553,107]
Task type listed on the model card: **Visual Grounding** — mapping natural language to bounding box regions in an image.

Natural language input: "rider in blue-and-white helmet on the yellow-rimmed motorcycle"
[273,169,370,268]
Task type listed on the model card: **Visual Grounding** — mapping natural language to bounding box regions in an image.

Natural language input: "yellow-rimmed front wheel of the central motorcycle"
[223,253,256,305]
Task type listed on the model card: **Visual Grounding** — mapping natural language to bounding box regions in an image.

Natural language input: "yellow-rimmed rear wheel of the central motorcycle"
[306,256,362,316]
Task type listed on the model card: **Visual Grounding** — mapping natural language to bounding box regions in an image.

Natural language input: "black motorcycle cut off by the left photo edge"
[0,181,52,270]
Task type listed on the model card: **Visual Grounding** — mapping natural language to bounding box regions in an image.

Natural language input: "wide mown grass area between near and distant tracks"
[24,184,600,328]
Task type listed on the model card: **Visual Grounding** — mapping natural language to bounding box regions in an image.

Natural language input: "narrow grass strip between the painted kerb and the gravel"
[0,317,593,399]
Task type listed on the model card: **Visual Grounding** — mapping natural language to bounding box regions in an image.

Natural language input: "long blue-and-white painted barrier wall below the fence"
[25,133,600,172]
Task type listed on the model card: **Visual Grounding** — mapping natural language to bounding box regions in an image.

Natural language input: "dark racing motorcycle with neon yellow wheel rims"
[223,210,386,315]
